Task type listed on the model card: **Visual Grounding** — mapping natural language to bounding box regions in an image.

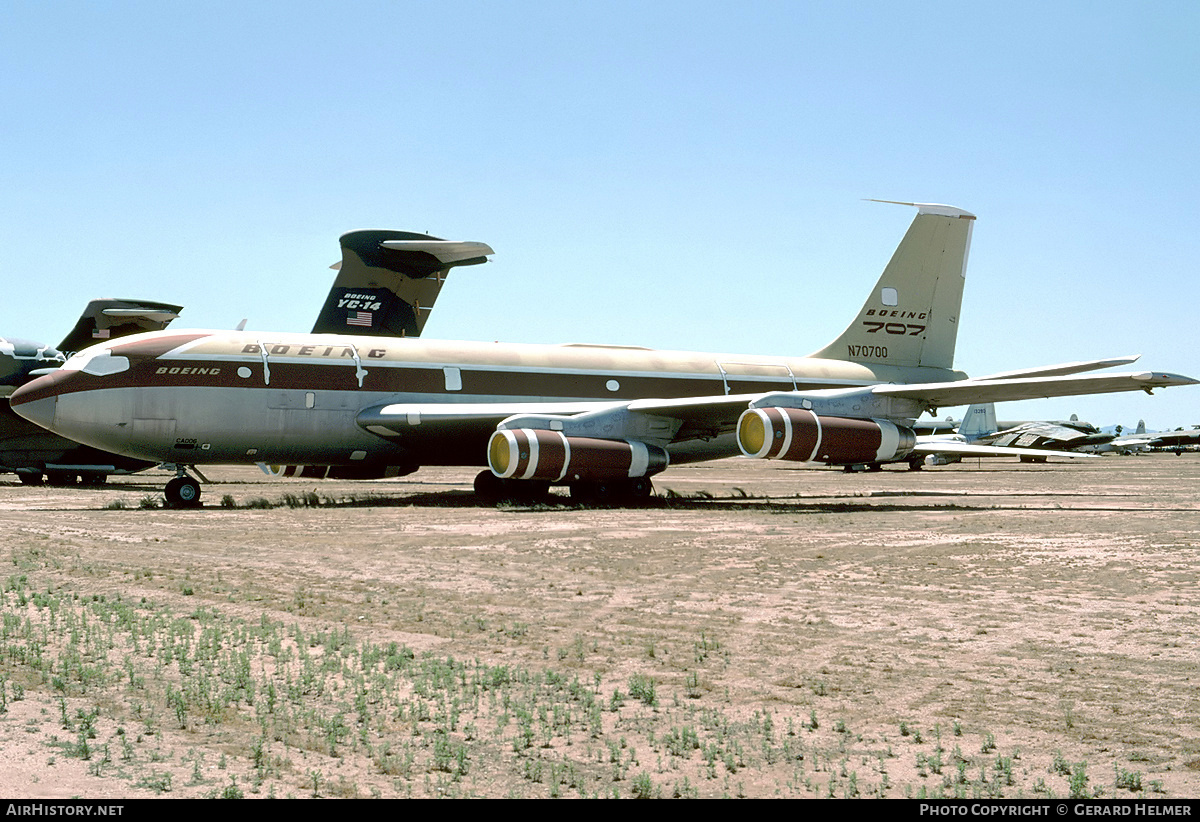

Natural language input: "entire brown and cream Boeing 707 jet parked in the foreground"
[12,203,1198,505]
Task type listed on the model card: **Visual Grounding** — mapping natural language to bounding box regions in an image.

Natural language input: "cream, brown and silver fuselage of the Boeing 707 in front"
[13,331,965,468]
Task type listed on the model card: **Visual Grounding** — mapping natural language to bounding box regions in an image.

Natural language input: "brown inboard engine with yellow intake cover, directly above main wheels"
[487,428,670,482]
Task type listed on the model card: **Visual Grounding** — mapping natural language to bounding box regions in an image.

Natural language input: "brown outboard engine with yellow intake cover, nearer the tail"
[738,408,917,466]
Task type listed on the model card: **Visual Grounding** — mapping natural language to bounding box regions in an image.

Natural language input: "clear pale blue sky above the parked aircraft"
[0,0,1200,428]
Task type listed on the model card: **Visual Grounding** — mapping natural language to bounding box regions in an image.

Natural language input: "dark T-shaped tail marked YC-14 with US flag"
[312,230,493,337]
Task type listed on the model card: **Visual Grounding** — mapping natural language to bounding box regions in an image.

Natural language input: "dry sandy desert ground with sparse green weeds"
[0,454,1200,798]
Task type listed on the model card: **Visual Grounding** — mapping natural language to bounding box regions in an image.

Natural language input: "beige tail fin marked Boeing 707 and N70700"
[812,200,976,368]
